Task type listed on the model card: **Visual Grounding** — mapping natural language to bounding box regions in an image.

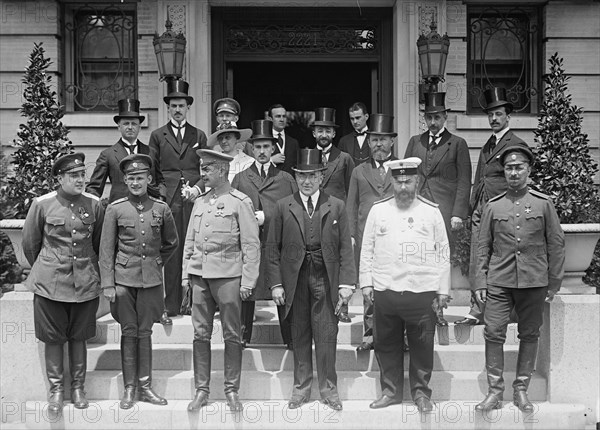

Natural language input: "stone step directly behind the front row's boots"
[77,370,546,401]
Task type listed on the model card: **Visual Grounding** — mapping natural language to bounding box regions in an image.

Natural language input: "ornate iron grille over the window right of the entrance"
[467,6,541,112]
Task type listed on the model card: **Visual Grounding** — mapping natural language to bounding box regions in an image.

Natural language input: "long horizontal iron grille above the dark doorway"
[225,25,379,54]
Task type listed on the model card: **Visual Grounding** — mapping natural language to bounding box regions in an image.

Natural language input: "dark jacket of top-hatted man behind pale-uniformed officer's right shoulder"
[231,163,298,300]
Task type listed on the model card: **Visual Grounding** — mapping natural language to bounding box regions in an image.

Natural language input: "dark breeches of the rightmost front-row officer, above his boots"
[483,285,548,344]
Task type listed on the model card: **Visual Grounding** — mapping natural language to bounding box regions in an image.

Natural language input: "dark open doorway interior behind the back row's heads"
[227,62,377,147]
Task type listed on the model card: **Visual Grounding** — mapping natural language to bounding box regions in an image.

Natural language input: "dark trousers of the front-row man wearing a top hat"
[291,252,339,399]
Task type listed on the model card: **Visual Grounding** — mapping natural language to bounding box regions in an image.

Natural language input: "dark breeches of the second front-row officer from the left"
[110,285,164,338]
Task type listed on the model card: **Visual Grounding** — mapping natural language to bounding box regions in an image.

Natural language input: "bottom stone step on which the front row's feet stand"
[7,400,585,430]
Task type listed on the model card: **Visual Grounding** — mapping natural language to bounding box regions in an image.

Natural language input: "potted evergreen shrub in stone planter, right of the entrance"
[531,53,600,291]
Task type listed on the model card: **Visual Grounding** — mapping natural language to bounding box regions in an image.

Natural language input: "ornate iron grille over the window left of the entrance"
[65,3,138,111]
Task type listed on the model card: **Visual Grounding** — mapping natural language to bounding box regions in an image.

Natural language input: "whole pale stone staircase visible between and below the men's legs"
[3,300,585,429]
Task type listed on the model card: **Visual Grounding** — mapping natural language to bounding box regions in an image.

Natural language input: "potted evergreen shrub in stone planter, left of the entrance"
[0,43,73,268]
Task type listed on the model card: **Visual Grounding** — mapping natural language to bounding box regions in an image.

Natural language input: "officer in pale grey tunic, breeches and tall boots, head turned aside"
[182,149,260,412]
